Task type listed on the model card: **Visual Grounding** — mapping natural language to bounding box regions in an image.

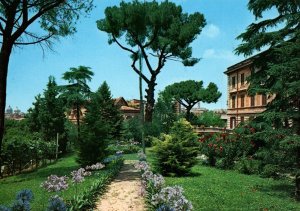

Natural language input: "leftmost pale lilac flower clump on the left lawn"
[41,175,68,192]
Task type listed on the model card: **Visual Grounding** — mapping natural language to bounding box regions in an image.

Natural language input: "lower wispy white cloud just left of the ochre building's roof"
[202,48,241,62]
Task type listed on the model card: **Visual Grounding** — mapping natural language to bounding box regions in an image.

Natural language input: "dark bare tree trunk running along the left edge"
[0,39,12,177]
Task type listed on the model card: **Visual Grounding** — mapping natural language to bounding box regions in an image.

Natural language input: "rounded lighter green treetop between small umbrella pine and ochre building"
[195,111,225,127]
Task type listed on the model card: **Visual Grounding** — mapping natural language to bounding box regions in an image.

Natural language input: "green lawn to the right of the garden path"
[147,149,300,211]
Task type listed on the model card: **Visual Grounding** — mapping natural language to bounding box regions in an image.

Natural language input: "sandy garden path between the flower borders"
[96,160,146,211]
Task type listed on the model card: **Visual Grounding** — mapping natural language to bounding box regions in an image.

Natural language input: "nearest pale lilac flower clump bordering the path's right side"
[151,186,193,211]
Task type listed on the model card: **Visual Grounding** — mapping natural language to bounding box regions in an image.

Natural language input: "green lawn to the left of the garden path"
[0,156,110,211]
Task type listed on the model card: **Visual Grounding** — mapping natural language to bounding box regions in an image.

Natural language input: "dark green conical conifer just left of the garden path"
[78,82,122,166]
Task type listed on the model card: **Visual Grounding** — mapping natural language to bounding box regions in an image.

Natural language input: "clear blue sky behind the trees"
[6,0,254,112]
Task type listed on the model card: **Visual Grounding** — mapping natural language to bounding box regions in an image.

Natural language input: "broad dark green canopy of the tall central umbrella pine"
[97,1,205,65]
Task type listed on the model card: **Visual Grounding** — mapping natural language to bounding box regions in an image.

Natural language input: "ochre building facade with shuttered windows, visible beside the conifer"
[224,58,270,129]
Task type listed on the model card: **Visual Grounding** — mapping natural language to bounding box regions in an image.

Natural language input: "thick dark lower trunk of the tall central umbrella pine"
[145,76,156,123]
